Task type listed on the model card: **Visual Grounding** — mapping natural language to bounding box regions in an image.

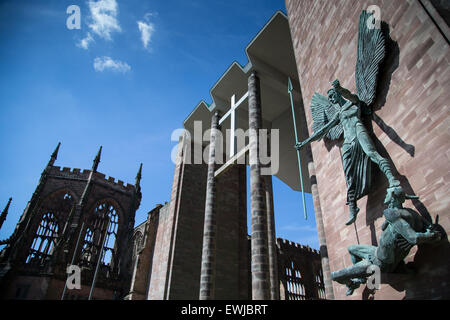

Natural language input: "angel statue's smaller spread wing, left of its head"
[311,92,344,140]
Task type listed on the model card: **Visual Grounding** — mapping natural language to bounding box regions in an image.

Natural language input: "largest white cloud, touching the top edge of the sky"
[88,0,122,40]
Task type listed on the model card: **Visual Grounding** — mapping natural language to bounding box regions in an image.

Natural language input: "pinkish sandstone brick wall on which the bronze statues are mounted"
[286,0,450,299]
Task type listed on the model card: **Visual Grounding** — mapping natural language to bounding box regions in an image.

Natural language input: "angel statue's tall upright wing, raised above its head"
[356,10,386,106]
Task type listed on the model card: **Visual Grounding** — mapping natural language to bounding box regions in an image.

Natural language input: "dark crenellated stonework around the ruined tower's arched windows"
[0,166,139,299]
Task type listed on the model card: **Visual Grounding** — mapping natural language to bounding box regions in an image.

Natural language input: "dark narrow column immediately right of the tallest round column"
[264,176,280,300]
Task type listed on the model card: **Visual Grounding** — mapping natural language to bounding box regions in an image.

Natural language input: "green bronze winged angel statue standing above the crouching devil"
[295,11,400,225]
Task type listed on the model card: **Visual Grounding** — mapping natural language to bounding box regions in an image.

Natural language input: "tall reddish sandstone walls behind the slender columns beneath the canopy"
[147,135,249,300]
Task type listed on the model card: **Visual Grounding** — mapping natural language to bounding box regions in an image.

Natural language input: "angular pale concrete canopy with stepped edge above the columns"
[183,11,311,192]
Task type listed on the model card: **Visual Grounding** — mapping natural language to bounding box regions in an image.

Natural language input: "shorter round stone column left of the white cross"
[200,112,219,300]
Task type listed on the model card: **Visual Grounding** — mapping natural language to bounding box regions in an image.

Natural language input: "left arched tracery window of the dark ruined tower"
[26,212,58,265]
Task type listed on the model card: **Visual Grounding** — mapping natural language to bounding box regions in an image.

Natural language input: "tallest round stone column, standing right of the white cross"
[248,72,270,300]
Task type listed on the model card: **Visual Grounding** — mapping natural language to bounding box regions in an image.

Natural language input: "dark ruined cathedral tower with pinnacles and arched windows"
[0,144,142,299]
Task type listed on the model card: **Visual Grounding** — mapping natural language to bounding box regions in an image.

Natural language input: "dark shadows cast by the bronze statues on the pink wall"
[362,22,450,300]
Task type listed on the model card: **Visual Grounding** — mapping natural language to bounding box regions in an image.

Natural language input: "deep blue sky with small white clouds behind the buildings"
[0,0,318,248]
